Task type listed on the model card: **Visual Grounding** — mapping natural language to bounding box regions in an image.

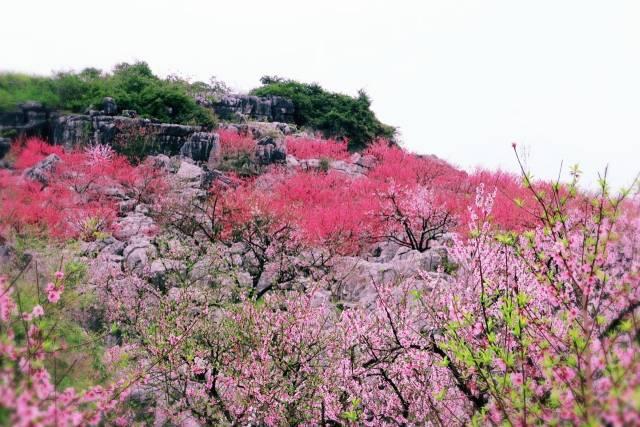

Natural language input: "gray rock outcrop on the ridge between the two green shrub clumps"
[212,94,295,123]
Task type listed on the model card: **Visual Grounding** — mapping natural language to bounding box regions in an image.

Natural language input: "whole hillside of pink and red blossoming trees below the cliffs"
[0,128,640,426]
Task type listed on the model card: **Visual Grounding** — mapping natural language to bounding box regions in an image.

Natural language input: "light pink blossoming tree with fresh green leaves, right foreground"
[410,160,640,425]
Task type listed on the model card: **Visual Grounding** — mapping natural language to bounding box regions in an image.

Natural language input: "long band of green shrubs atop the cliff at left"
[0,62,216,127]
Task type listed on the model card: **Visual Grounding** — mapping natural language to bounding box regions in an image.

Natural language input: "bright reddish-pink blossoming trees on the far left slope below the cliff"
[0,138,166,240]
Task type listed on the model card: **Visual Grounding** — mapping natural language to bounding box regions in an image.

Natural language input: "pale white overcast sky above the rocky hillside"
[0,0,640,189]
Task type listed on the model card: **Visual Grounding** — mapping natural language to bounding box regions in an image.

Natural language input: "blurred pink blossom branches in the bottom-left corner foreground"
[0,272,129,426]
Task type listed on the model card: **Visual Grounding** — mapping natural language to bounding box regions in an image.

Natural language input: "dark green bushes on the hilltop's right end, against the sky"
[252,76,395,150]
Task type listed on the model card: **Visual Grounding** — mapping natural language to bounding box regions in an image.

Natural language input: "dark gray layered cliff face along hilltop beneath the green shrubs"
[0,95,294,162]
